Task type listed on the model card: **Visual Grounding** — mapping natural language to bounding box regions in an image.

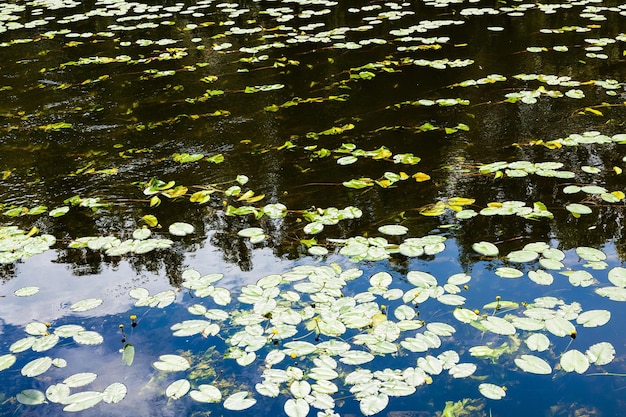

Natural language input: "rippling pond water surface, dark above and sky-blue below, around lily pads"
[0,1,626,417]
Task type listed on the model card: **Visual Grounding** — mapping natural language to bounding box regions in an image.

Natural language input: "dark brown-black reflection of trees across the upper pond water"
[0,2,624,285]
